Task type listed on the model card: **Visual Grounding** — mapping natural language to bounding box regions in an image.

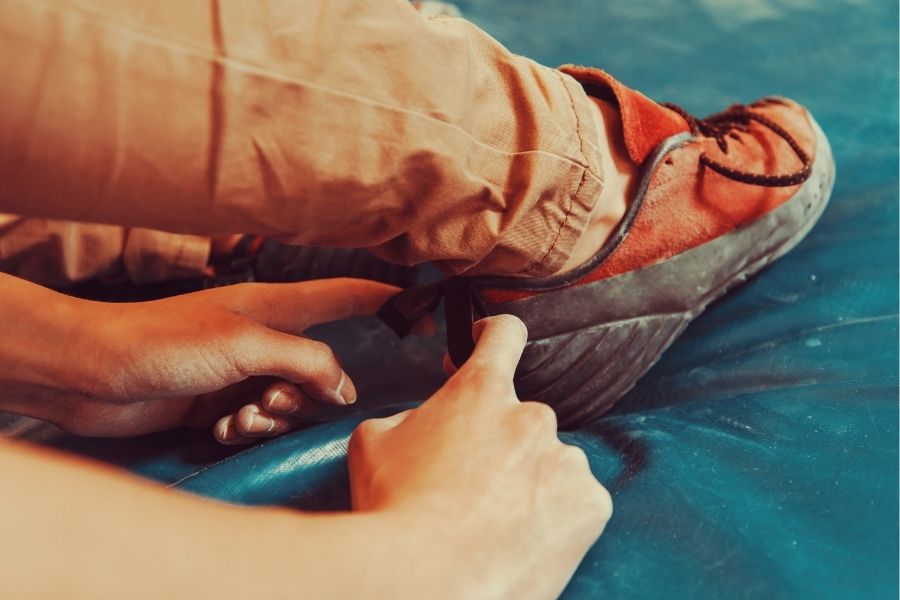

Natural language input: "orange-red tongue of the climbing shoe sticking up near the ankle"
[559,65,690,164]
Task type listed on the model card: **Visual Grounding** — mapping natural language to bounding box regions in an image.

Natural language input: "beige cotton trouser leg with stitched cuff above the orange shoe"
[0,0,602,275]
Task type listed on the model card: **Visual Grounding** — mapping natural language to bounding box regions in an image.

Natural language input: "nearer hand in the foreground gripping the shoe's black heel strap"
[348,315,612,598]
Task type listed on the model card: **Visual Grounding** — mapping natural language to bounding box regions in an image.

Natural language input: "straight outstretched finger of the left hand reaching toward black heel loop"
[226,277,410,334]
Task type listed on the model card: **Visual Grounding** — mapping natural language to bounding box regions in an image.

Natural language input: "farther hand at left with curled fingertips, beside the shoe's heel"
[32,279,433,443]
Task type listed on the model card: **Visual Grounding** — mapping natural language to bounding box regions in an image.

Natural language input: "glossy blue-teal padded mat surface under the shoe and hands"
[3,0,898,599]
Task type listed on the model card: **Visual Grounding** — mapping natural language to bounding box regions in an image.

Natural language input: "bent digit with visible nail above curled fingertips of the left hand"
[236,326,356,406]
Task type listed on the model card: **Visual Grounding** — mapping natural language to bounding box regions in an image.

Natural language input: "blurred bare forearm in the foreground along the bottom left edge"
[0,443,449,599]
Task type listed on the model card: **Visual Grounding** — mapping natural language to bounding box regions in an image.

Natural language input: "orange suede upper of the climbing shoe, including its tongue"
[482,66,815,302]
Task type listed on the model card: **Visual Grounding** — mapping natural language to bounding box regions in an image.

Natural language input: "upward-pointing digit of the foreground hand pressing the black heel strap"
[461,315,528,380]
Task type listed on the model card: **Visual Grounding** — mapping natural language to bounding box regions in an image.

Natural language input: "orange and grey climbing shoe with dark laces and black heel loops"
[382,66,834,427]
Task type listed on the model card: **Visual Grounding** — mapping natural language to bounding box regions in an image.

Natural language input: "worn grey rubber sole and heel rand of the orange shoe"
[484,117,834,428]
